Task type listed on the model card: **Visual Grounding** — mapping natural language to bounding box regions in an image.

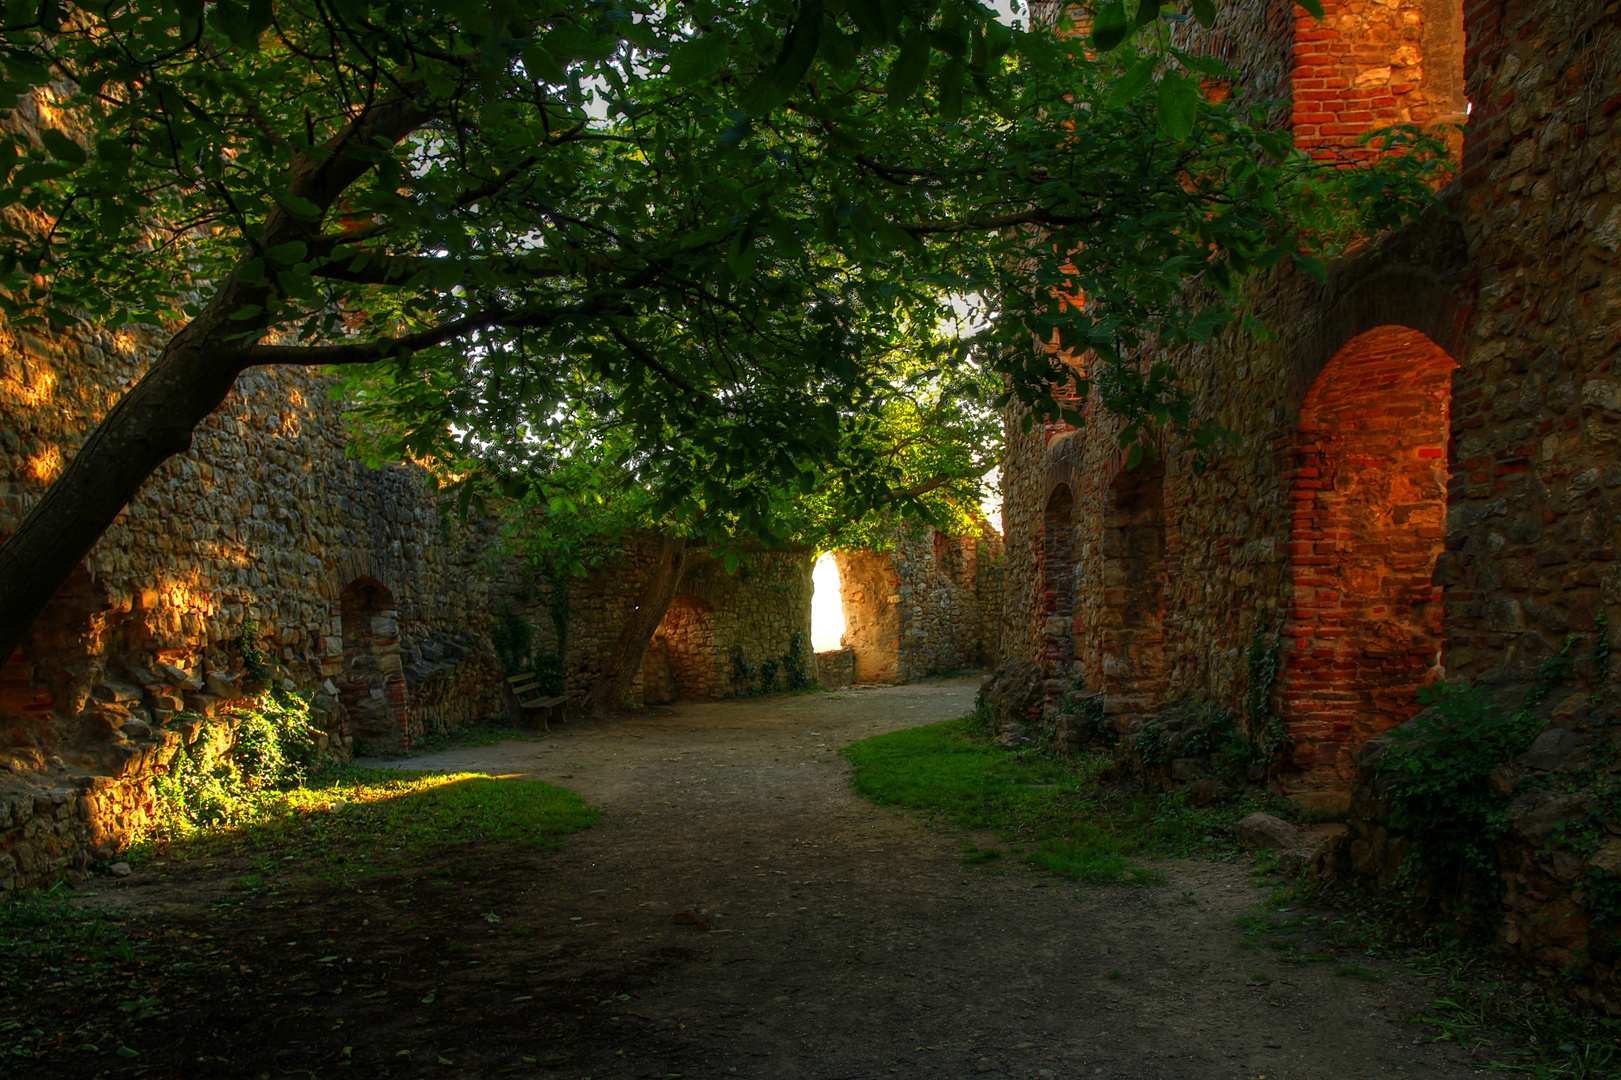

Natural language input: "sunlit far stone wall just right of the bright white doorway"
[833,521,1003,683]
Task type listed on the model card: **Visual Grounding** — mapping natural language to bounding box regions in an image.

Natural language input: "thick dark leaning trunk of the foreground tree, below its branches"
[0,318,243,665]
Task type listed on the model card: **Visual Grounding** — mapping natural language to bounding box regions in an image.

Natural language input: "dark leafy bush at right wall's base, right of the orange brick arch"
[1386,683,1546,929]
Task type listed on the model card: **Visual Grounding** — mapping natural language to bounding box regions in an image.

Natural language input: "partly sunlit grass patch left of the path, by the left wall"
[131,767,600,877]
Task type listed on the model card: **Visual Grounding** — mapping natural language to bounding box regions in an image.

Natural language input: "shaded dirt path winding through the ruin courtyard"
[351,679,1483,1080]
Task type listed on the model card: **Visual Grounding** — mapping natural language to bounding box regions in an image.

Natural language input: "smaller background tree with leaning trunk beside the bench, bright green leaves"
[398,345,1000,712]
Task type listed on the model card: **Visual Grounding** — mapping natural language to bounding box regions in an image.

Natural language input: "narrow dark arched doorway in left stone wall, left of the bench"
[337,577,408,749]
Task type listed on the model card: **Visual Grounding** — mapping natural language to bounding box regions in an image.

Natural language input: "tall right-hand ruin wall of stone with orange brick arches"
[1002,0,1621,809]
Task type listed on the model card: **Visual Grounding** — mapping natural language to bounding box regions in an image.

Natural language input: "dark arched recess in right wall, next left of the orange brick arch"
[1101,461,1165,730]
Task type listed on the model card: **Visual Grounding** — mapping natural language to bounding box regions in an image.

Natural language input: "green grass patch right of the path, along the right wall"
[841,718,1261,884]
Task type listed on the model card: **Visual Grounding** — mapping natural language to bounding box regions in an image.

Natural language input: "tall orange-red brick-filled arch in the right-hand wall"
[1279,326,1457,790]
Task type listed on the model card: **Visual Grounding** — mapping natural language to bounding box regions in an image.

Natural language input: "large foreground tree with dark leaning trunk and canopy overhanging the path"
[0,0,1433,657]
